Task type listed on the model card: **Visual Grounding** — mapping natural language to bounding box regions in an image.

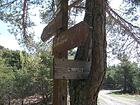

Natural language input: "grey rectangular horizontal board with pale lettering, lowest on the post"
[54,59,90,79]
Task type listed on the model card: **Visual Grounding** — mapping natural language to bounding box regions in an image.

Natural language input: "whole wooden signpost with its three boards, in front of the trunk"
[41,0,90,105]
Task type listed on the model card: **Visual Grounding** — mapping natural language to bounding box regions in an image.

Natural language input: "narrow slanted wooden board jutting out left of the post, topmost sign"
[41,12,62,42]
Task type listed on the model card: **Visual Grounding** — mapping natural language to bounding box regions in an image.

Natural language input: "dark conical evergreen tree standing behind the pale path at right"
[118,55,137,93]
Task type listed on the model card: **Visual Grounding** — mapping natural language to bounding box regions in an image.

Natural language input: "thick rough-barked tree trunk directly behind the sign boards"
[69,0,106,105]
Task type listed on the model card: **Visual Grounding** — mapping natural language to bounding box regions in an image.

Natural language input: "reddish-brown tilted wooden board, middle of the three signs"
[53,21,89,53]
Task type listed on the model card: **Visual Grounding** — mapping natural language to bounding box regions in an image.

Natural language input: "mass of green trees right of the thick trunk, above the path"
[104,55,140,93]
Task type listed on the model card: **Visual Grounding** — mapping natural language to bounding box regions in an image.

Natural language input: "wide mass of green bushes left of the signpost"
[0,46,52,104]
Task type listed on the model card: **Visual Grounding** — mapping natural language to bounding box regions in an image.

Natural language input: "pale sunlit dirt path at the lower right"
[98,90,140,105]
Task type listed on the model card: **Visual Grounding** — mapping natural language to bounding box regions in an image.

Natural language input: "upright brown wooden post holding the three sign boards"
[53,0,68,105]
